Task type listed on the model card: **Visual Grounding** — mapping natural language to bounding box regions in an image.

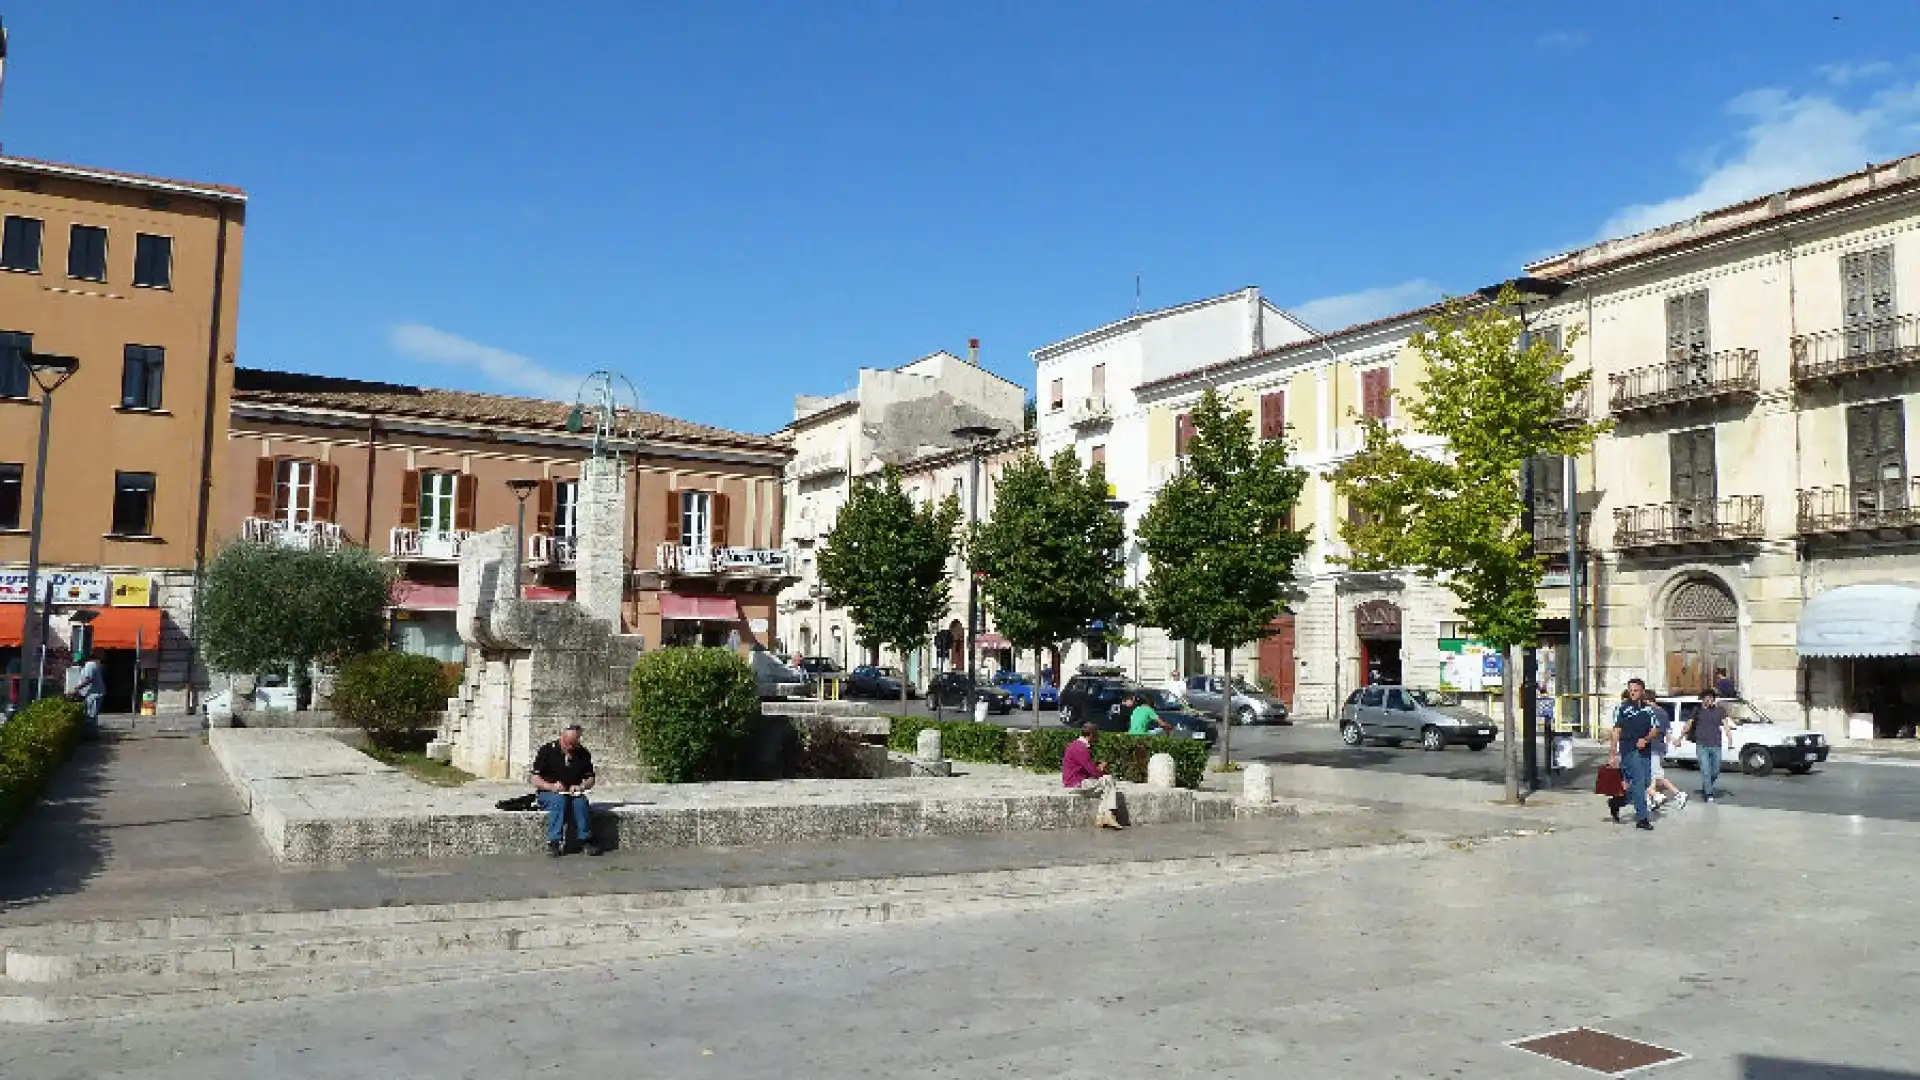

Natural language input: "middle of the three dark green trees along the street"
[968,450,1137,723]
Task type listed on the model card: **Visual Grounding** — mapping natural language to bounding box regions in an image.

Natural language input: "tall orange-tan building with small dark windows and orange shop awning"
[0,158,246,711]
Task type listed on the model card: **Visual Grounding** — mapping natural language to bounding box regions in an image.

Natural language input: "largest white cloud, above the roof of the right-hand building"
[1599,83,1920,238]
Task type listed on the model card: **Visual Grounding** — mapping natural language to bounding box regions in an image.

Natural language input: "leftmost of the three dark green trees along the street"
[820,467,960,709]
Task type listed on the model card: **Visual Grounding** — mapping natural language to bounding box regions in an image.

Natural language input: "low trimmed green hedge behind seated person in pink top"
[887,717,1208,788]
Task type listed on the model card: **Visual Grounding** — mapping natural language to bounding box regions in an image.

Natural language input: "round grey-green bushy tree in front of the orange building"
[200,540,392,690]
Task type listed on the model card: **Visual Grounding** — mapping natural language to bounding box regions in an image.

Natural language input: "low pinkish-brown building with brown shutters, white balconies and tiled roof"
[221,369,793,661]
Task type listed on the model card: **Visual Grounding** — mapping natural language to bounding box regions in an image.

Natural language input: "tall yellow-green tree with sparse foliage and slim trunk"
[1334,286,1605,801]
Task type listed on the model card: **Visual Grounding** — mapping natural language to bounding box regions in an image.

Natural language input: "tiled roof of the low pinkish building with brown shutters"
[234,367,791,454]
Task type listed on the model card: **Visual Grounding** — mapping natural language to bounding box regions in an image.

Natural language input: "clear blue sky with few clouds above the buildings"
[0,0,1920,430]
